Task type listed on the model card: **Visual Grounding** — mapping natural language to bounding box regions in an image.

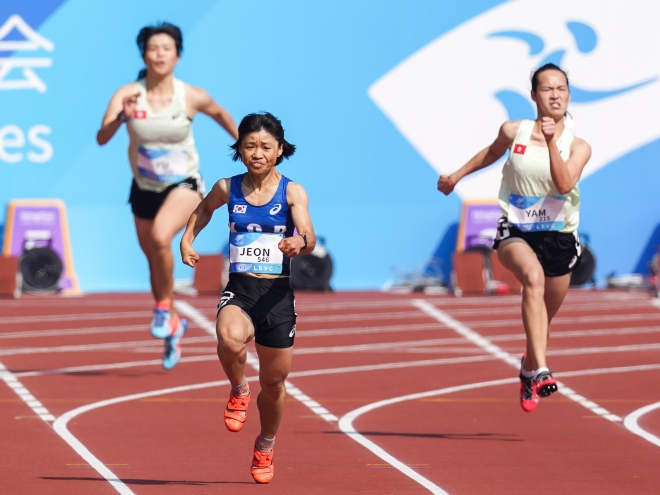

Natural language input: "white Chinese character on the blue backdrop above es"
[0,14,55,93]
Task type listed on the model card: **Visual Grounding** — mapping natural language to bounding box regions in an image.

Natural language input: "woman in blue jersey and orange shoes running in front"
[181,113,316,483]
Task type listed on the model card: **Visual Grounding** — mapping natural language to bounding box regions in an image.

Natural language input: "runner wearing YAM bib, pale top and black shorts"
[438,64,591,412]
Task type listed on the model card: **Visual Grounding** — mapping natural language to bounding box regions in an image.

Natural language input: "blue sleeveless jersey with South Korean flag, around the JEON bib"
[227,174,294,276]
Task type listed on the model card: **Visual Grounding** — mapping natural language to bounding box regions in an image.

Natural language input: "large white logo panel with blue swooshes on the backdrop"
[369,0,660,199]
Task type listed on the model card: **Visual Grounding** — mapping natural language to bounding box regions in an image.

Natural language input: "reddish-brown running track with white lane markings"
[0,291,660,495]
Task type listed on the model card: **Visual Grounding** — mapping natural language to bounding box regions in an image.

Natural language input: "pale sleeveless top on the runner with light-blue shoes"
[127,79,199,192]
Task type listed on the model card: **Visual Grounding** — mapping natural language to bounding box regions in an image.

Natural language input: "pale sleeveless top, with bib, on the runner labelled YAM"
[499,120,580,232]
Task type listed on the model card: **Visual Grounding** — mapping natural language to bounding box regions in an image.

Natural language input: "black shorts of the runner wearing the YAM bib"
[493,217,582,277]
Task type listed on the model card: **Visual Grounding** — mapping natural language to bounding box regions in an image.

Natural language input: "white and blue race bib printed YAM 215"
[507,194,564,232]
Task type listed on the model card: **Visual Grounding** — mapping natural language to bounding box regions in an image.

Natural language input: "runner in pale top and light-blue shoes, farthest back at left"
[96,23,238,369]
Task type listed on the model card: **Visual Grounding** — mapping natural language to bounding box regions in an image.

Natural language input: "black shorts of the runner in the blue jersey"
[218,273,296,349]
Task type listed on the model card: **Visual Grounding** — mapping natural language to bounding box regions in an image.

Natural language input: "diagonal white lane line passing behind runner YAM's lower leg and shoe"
[412,299,622,422]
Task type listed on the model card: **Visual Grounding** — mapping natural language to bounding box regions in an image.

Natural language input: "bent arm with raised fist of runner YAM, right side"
[541,117,591,194]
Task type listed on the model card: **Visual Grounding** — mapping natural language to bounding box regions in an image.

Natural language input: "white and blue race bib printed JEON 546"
[229,232,284,275]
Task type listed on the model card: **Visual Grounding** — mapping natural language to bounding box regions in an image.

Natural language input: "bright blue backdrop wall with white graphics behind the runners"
[0,0,660,291]
